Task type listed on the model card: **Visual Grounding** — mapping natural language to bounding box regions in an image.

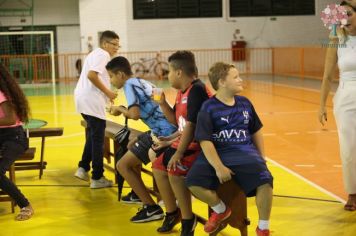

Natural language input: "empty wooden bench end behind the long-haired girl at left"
[15,128,63,179]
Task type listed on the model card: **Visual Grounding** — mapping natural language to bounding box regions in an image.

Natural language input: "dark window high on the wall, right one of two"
[229,0,315,17]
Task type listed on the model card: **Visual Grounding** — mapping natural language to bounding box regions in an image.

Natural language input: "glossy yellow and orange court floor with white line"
[0,78,356,236]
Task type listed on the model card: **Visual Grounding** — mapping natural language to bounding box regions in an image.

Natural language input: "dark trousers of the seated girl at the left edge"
[0,126,30,208]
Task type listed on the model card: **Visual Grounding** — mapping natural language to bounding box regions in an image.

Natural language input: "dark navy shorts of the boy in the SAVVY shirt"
[186,162,273,197]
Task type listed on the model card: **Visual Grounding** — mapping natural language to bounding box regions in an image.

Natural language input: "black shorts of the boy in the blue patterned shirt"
[130,131,168,165]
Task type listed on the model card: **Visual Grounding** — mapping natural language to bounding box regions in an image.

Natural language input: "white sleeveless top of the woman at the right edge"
[337,35,356,81]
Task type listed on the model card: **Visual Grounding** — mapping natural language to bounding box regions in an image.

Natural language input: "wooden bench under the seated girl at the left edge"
[0,148,36,213]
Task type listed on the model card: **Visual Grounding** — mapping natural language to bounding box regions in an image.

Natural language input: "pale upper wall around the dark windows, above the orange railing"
[0,0,335,52]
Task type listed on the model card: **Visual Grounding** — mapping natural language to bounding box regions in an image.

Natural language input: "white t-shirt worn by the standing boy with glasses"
[74,48,110,120]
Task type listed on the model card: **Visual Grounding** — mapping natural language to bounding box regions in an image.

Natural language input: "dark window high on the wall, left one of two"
[133,0,222,19]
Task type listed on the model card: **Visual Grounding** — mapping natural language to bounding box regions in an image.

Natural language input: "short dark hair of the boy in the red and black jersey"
[168,51,198,77]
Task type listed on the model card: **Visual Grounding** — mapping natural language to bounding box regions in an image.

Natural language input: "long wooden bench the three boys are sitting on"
[81,120,250,236]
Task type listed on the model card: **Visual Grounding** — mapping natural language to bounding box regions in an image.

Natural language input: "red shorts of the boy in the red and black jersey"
[152,147,201,176]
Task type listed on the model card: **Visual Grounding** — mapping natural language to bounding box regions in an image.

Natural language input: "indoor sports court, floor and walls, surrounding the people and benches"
[0,0,356,236]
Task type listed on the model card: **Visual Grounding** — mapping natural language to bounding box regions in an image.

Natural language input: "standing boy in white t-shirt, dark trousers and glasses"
[74,31,120,188]
